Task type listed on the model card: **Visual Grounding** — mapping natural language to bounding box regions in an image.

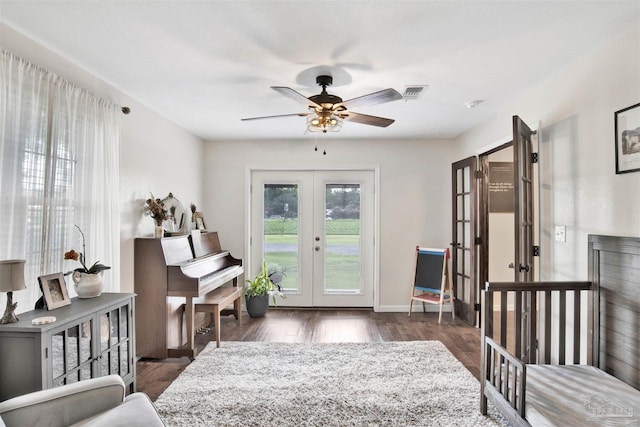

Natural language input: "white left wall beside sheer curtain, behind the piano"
[0,23,203,298]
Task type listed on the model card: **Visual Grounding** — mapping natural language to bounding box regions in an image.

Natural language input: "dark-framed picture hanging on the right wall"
[615,104,640,174]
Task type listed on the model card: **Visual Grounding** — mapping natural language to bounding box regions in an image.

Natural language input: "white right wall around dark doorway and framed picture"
[455,23,640,280]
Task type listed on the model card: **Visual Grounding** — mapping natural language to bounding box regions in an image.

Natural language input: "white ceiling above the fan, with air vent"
[0,0,640,140]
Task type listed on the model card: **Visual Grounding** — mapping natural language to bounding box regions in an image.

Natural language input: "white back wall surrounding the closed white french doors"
[203,139,452,311]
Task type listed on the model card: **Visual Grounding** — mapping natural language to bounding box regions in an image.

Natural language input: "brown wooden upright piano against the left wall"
[134,232,244,359]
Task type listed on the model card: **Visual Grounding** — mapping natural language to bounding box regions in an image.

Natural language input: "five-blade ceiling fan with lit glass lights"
[241,75,402,133]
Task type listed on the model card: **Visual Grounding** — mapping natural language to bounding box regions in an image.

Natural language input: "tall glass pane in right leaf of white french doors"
[318,184,361,293]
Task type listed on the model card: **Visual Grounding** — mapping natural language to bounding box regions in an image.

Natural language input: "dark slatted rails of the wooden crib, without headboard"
[480,281,598,425]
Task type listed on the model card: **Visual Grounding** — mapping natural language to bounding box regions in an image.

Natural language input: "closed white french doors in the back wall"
[250,170,375,307]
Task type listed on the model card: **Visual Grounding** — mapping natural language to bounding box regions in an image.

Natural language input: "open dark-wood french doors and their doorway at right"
[451,116,537,328]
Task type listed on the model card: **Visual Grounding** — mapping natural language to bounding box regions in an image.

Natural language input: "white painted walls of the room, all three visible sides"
[0,15,640,310]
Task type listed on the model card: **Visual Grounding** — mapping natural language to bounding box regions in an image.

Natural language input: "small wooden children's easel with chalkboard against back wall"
[409,246,456,323]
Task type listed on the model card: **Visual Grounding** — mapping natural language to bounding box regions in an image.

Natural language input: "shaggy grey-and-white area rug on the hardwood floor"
[155,341,503,427]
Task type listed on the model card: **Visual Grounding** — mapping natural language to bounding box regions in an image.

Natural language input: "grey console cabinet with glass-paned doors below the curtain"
[0,293,136,401]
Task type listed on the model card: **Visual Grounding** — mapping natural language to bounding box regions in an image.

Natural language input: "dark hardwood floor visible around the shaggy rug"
[136,308,480,400]
